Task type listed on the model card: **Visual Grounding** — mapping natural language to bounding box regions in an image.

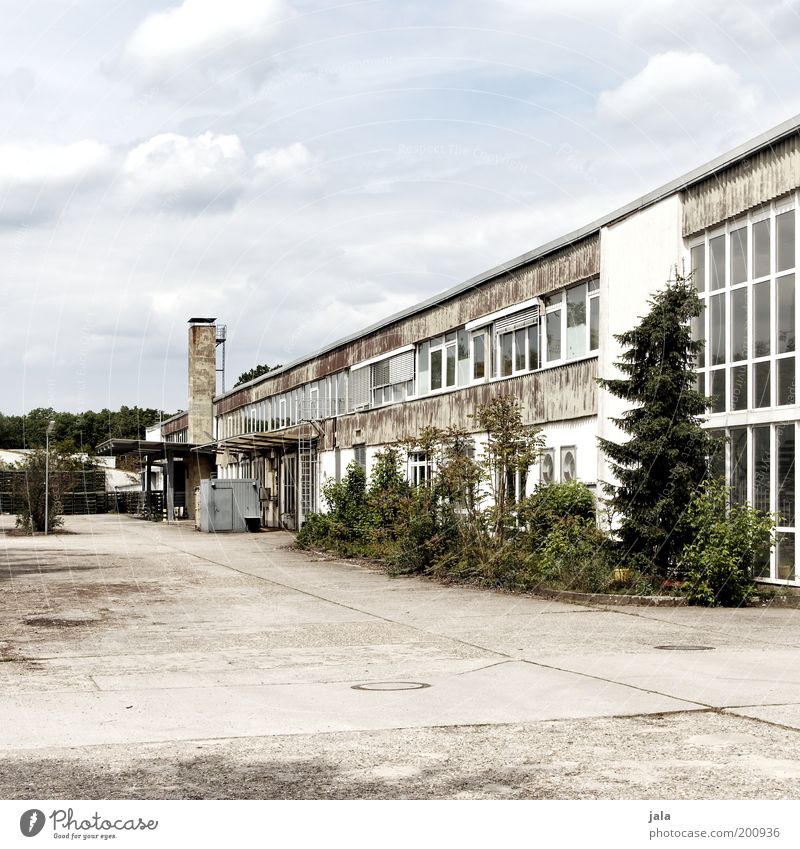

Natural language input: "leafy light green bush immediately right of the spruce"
[680,478,778,607]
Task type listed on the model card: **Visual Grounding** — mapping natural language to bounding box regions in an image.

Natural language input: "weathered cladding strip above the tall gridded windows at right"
[683,134,800,237]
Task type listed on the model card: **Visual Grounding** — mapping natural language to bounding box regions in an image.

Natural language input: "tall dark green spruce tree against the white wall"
[598,269,721,576]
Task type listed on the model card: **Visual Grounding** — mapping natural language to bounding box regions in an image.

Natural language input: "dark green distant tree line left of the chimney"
[0,406,178,452]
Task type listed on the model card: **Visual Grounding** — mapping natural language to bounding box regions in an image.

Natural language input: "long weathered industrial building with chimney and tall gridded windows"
[122,117,800,584]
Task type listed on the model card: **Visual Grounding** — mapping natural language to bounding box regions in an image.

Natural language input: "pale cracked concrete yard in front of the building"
[0,516,800,799]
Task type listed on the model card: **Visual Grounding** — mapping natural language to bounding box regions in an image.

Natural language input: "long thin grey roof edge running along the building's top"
[214,115,800,401]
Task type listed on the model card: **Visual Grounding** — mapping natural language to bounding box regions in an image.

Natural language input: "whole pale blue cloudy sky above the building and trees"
[0,0,800,414]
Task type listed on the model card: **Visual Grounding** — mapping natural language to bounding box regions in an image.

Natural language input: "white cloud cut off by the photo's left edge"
[0,139,112,227]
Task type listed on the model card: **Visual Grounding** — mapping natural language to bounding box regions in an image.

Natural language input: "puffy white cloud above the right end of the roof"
[598,51,760,139]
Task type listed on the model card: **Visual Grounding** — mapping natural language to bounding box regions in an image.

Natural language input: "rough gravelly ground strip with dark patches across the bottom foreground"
[0,712,800,799]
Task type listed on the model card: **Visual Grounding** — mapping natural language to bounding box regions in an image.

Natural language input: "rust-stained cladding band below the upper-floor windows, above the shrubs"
[320,359,597,450]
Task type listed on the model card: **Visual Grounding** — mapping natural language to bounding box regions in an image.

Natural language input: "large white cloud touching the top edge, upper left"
[123,0,288,86]
